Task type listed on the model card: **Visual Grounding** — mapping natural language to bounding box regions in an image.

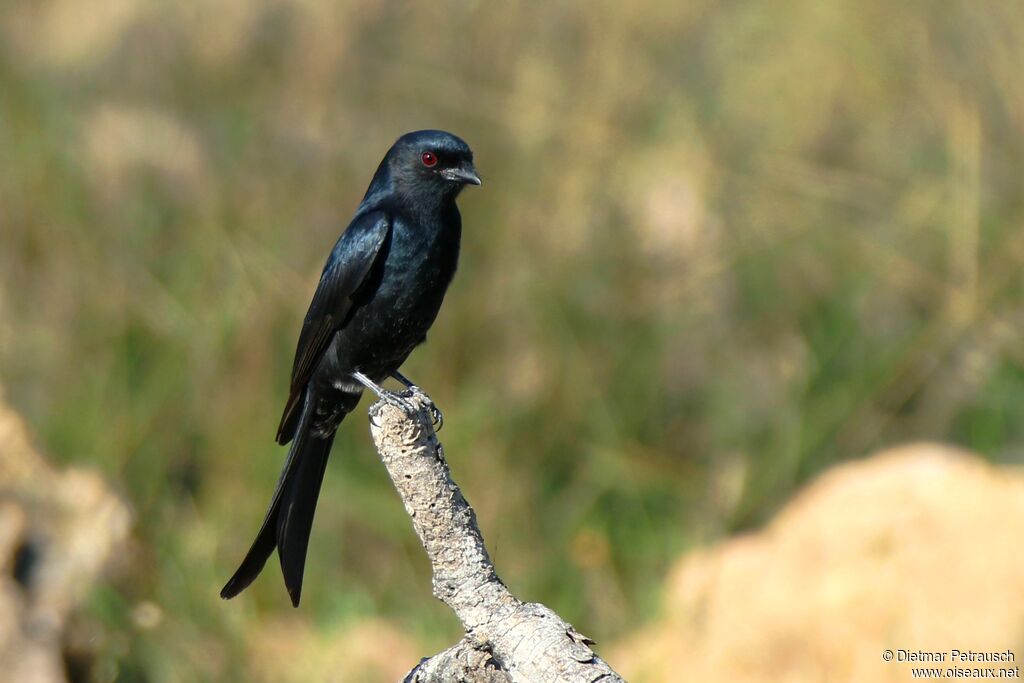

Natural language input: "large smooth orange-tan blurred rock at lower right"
[609,444,1024,683]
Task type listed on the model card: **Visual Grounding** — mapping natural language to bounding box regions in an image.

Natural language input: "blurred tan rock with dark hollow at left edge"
[0,395,130,683]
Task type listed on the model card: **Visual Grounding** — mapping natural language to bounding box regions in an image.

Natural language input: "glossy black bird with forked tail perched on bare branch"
[220,130,480,607]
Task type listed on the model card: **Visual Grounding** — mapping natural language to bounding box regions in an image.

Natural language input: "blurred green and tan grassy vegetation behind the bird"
[0,0,1024,682]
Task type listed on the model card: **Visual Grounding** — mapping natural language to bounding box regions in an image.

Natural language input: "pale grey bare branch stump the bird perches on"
[370,394,623,683]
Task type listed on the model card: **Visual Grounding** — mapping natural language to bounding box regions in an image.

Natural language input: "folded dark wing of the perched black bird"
[278,212,391,444]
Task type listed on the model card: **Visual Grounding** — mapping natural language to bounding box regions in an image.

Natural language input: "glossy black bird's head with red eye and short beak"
[388,130,481,198]
